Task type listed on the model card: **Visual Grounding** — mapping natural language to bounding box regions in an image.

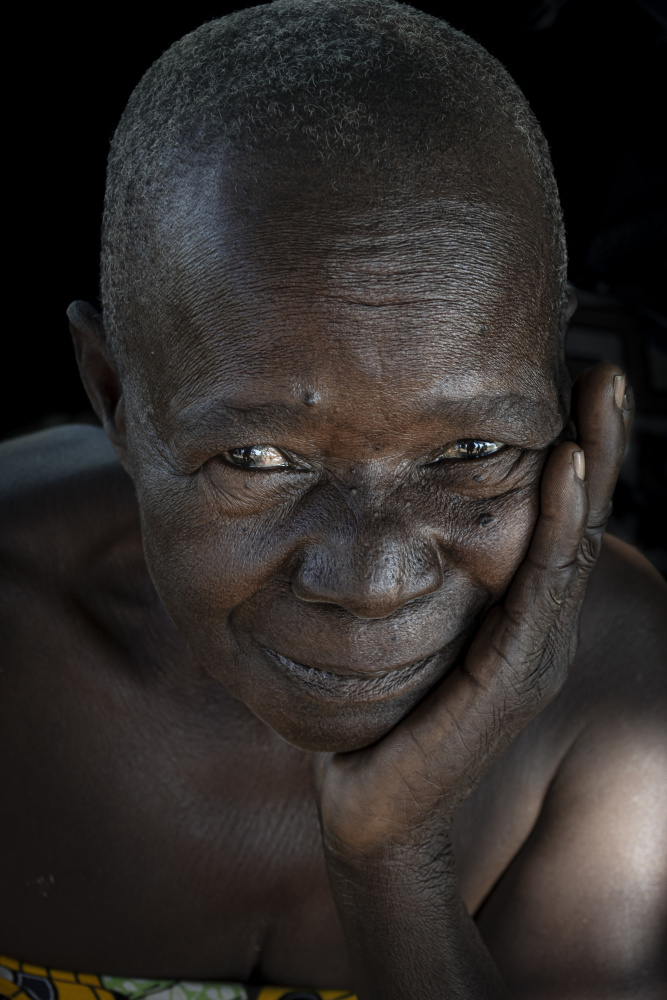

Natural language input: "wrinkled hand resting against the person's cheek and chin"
[317,365,632,853]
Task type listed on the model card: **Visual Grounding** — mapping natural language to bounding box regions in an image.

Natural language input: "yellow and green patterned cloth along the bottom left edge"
[0,955,356,1000]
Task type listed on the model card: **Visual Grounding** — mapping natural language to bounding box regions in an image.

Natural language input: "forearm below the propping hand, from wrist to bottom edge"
[326,843,509,1000]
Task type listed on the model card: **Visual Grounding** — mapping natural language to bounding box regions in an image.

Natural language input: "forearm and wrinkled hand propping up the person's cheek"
[319,366,629,1000]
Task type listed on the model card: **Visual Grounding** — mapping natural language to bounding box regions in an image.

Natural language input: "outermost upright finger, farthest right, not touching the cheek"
[573,365,633,535]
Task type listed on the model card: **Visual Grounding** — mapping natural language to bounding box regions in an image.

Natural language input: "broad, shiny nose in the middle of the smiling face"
[292,520,443,618]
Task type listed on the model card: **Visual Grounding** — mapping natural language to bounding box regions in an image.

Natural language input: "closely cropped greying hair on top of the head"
[101,0,566,367]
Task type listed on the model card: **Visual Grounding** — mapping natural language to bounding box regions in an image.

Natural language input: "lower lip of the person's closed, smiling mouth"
[261,647,448,701]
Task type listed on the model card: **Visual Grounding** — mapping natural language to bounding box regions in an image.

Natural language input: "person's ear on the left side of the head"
[67,302,127,462]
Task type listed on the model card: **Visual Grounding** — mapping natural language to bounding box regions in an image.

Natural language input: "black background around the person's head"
[6,0,667,572]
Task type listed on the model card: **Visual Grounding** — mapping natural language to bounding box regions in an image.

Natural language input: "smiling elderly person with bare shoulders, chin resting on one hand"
[0,0,667,1000]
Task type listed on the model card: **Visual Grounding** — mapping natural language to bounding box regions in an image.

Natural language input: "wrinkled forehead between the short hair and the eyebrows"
[126,171,559,422]
